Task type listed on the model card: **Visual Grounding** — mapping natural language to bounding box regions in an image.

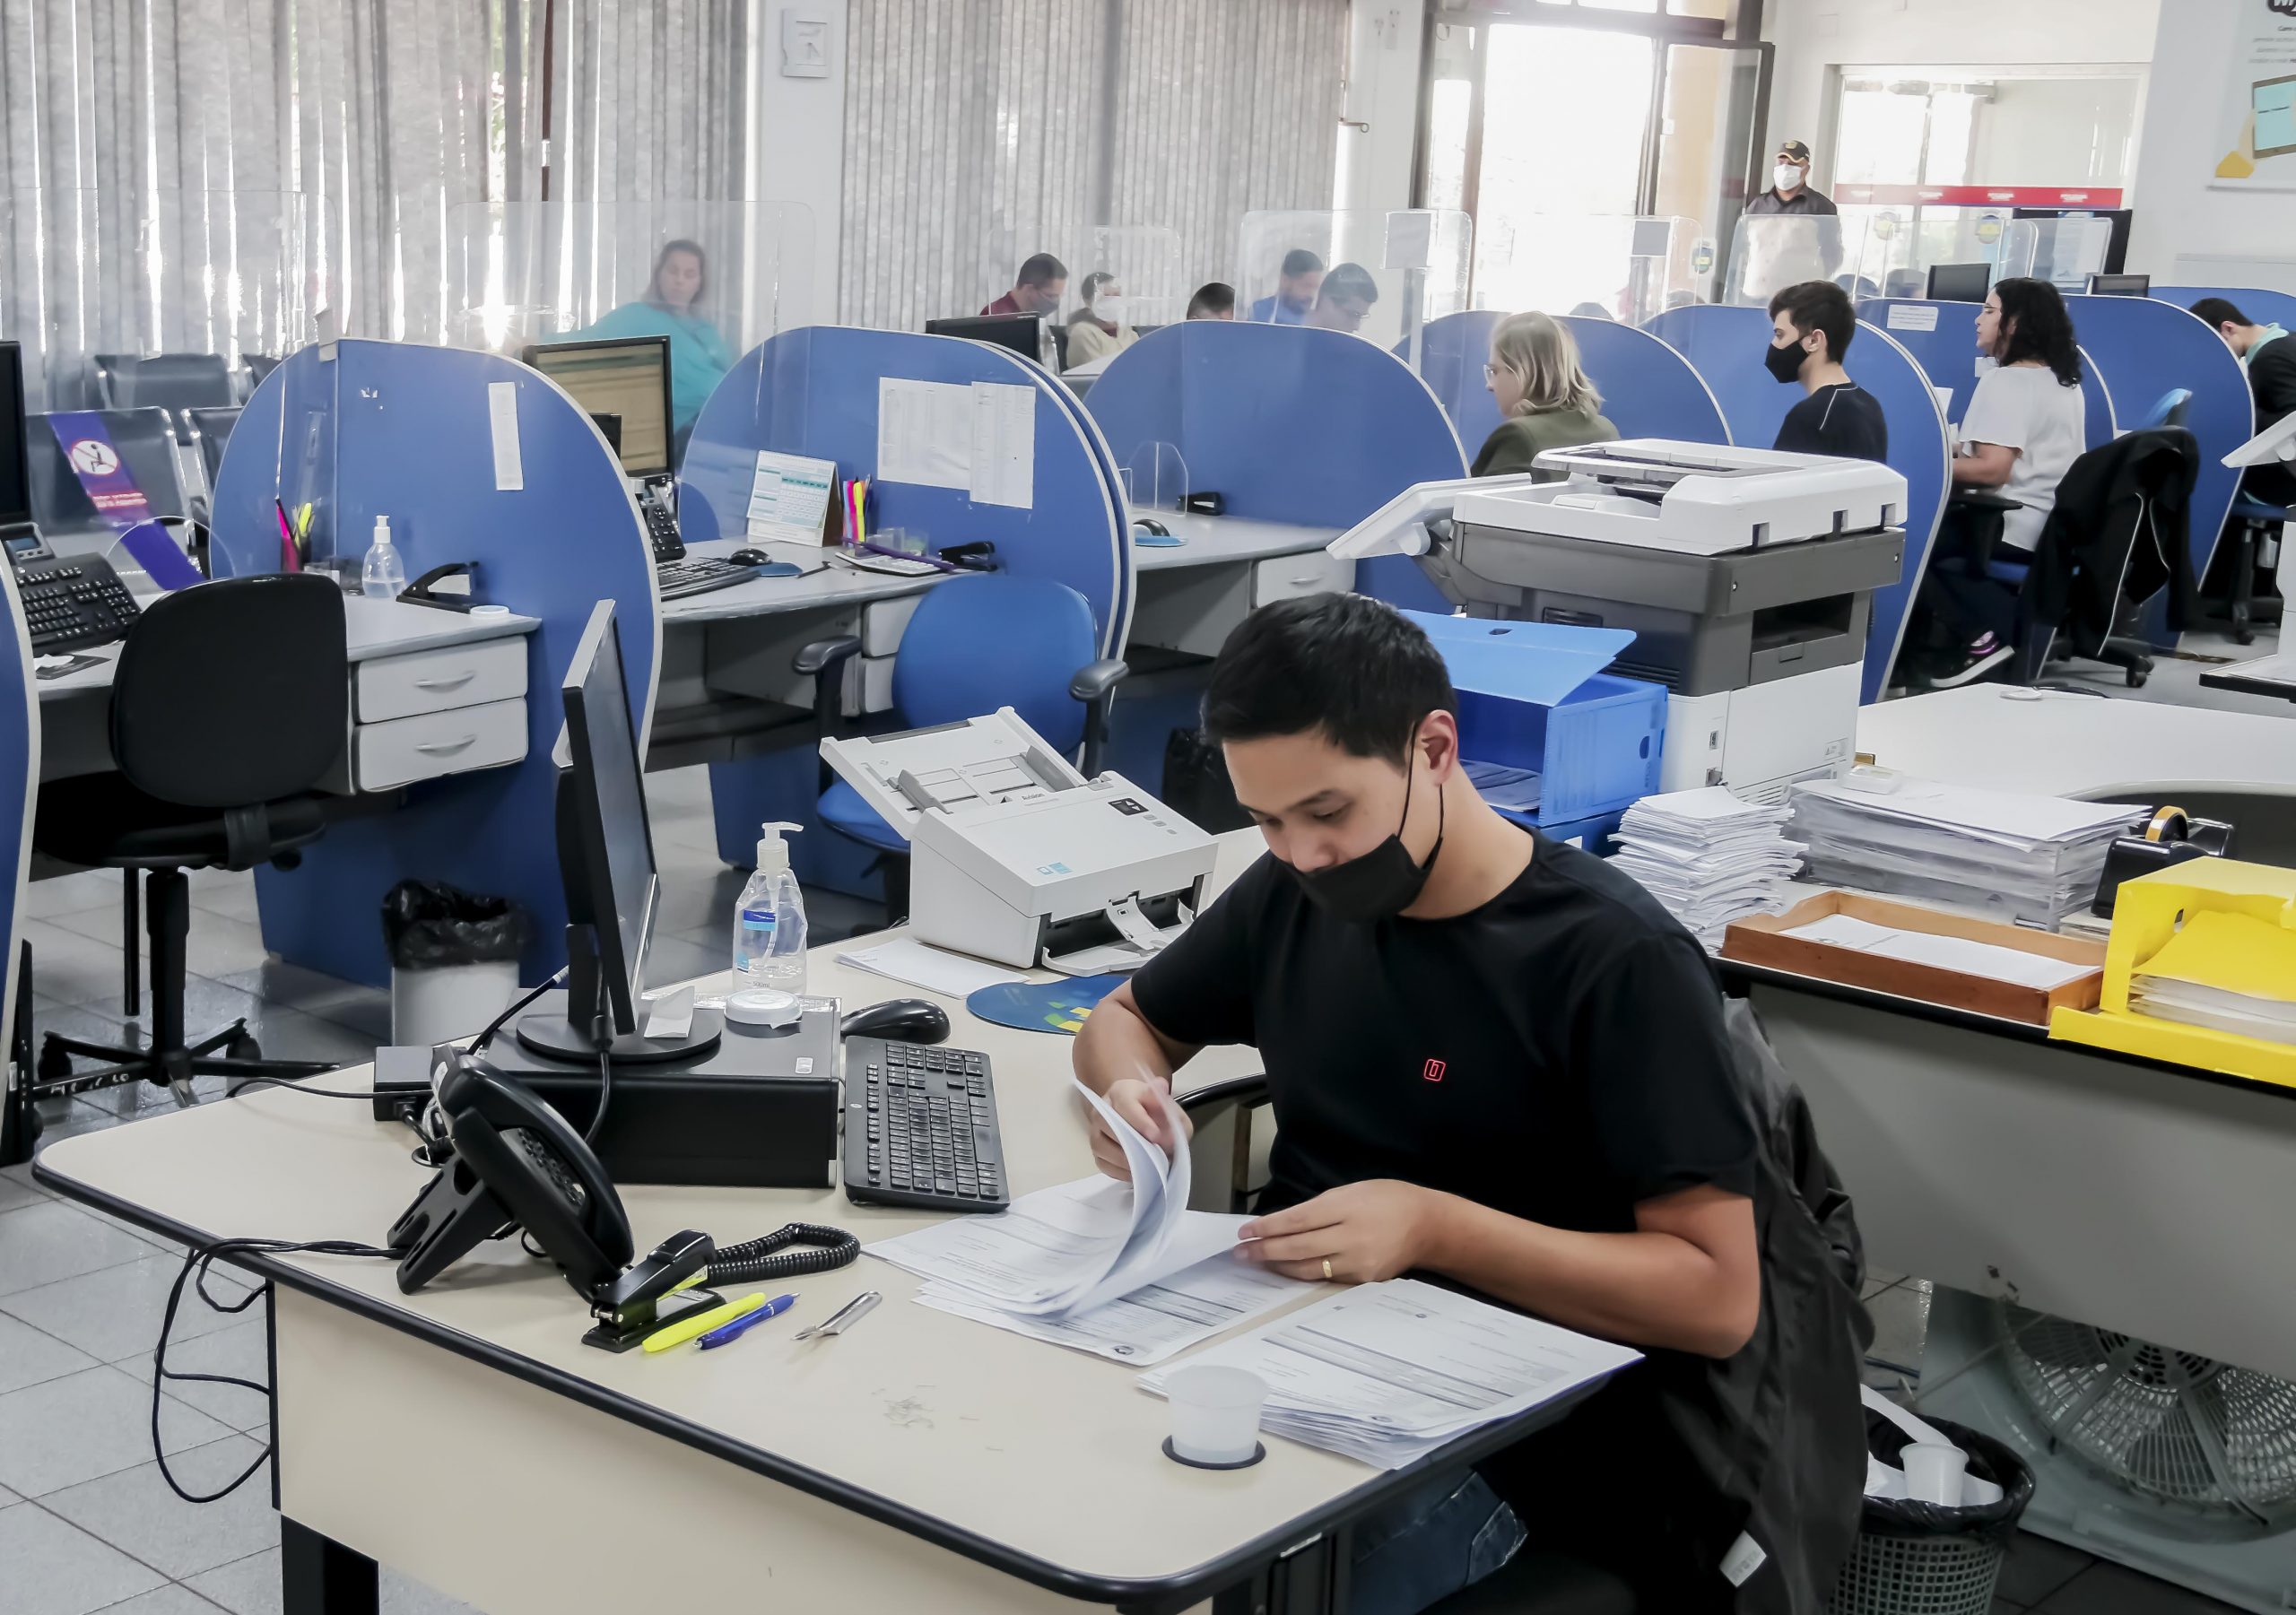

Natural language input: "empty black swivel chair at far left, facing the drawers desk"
[32,574,349,1104]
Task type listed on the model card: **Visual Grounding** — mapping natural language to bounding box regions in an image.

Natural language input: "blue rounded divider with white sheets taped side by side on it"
[677,326,1132,651]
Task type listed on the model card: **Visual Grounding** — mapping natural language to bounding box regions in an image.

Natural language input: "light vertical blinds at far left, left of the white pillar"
[0,0,749,406]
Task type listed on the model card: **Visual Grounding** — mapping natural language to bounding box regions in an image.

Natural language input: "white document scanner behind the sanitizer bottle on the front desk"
[822,707,1214,975]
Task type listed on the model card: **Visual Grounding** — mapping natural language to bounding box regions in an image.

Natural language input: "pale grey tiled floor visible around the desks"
[0,729,2268,1615]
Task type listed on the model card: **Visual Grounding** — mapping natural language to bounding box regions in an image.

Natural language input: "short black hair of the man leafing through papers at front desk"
[1203,595,1458,766]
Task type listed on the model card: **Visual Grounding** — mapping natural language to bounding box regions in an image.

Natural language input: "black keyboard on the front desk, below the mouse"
[843,1037,1005,1211]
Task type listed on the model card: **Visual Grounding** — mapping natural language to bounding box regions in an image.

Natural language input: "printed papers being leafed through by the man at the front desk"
[868,1085,1309,1363]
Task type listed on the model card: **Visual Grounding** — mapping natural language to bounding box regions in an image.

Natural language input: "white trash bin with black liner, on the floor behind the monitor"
[384,881,533,1044]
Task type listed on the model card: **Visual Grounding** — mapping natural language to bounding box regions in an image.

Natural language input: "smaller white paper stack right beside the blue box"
[1610,785,1803,948]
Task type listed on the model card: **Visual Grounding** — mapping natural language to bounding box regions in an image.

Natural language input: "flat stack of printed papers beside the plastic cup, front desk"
[1139,1278,1641,1468]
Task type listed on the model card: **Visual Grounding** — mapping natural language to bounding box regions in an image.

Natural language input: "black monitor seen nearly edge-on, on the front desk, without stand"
[562,601,661,1035]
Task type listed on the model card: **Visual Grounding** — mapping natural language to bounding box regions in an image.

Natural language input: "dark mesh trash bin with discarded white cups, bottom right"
[1825,1409,2032,1615]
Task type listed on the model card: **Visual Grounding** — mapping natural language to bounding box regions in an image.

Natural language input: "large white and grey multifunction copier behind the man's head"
[1332,438,1906,801]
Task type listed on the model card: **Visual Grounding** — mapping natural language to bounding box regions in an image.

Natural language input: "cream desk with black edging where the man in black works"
[34,835,1625,1615]
